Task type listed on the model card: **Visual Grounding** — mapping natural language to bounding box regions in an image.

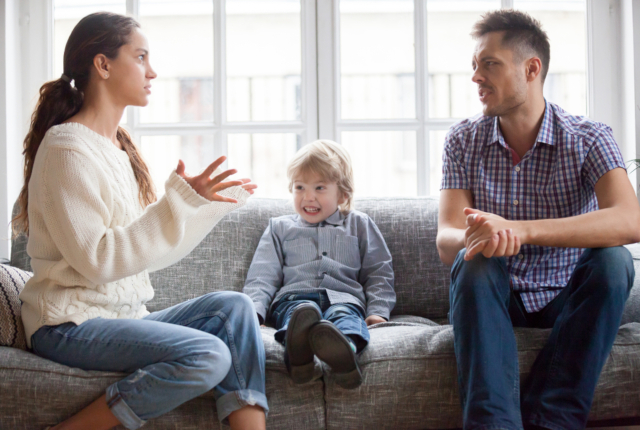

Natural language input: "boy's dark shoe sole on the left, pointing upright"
[285,305,322,384]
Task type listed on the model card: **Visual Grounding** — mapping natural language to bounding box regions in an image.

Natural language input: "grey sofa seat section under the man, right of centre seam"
[323,321,640,430]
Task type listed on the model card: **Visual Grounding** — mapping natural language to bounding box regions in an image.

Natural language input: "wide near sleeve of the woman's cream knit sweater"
[35,147,248,285]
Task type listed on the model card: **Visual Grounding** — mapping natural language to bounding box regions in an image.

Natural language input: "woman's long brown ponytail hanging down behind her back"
[11,75,83,236]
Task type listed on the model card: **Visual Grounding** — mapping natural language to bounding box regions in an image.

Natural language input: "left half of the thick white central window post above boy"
[300,0,319,145]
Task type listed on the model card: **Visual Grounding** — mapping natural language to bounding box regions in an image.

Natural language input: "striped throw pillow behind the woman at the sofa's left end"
[0,264,33,349]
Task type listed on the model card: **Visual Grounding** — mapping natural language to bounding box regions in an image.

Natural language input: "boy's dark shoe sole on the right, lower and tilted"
[309,322,362,389]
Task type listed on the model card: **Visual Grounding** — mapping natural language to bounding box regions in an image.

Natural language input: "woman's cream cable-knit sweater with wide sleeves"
[20,123,249,346]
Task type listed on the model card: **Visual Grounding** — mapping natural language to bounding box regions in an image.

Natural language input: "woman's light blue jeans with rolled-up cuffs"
[31,292,268,429]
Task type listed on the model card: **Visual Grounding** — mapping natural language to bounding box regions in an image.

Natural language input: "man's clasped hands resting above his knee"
[464,208,522,261]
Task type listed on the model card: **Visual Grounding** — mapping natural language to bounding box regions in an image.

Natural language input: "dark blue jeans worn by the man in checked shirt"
[450,246,635,430]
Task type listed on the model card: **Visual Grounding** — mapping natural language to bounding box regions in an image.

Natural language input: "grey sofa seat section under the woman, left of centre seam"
[0,327,325,430]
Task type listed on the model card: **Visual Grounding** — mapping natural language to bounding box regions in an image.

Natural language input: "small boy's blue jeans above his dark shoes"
[270,291,369,352]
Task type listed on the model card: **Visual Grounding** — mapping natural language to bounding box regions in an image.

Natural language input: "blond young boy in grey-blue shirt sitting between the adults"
[243,140,396,388]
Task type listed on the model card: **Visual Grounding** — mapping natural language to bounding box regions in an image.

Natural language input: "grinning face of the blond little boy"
[293,173,345,224]
